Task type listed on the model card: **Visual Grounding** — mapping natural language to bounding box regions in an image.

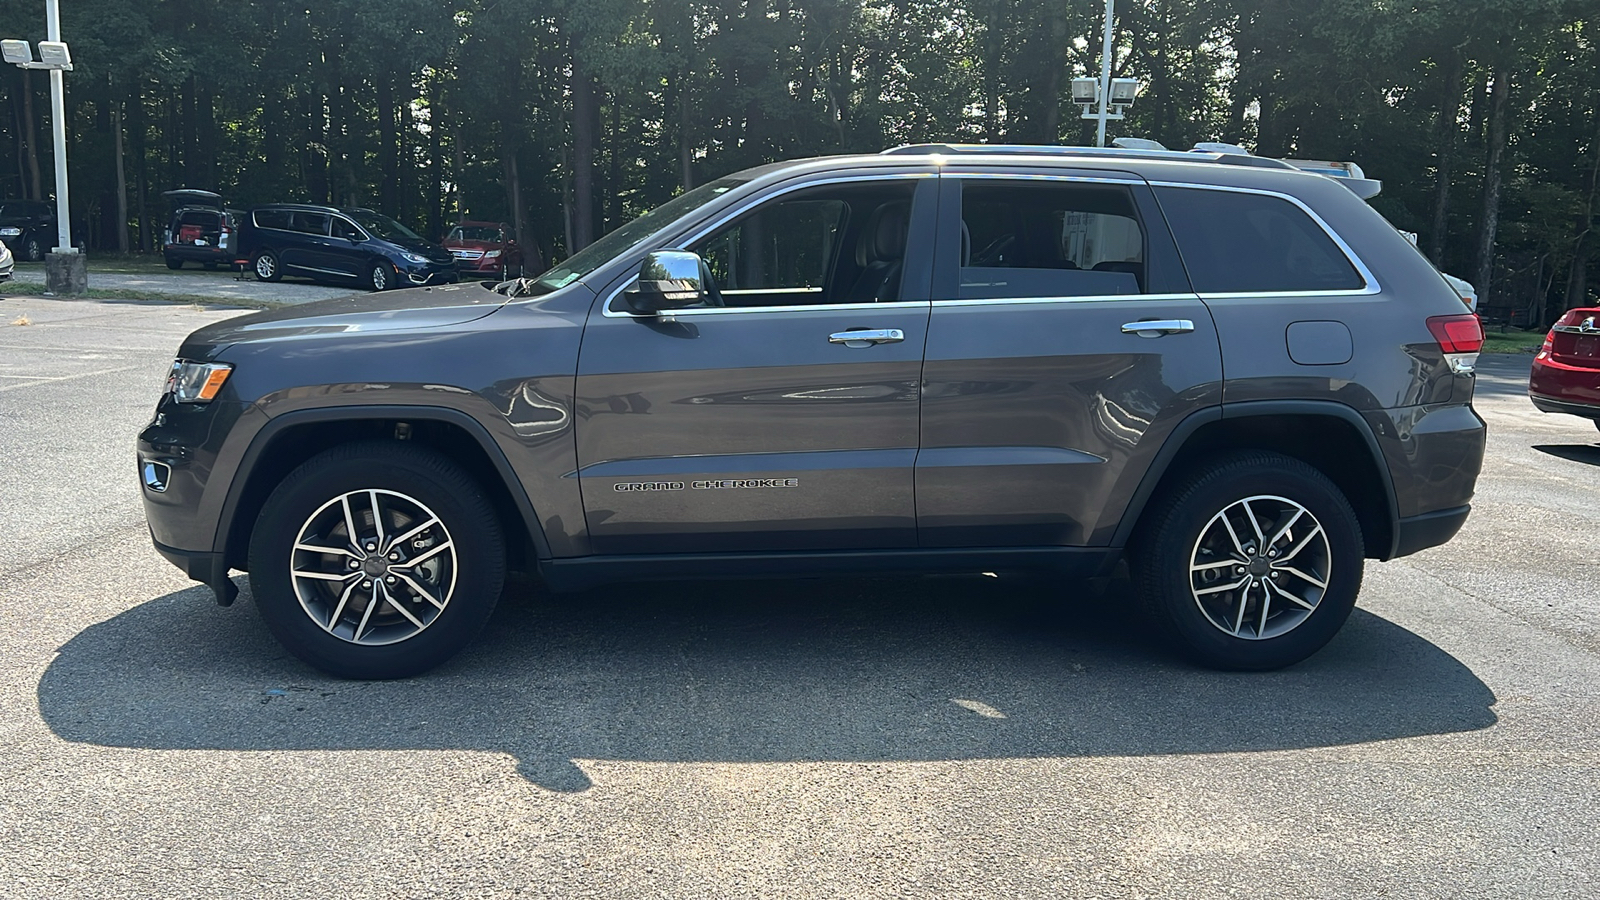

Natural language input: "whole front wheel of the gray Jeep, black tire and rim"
[250,442,506,679]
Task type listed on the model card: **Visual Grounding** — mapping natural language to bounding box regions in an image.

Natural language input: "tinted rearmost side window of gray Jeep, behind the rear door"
[1155,187,1366,295]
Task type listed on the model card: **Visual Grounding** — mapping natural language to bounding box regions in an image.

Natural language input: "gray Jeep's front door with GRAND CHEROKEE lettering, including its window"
[576,175,938,554]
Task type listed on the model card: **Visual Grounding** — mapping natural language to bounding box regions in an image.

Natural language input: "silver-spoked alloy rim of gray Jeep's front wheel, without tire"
[290,490,459,645]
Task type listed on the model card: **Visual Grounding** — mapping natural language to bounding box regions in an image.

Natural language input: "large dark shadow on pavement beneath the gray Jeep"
[38,577,1496,791]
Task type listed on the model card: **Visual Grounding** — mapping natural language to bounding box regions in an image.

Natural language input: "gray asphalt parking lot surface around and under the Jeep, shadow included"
[0,299,1600,898]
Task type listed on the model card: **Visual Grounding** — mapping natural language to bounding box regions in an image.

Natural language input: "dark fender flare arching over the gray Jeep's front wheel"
[211,404,550,560]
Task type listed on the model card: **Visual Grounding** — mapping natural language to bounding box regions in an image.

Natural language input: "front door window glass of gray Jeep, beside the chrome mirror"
[690,181,914,307]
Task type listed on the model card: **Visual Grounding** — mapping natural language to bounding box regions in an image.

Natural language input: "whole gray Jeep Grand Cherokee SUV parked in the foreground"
[138,146,1485,677]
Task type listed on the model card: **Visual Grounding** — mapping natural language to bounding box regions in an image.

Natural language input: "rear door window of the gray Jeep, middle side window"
[958,179,1146,299]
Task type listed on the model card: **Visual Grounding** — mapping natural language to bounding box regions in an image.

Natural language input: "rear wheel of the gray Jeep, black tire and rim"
[1131,452,1365,671]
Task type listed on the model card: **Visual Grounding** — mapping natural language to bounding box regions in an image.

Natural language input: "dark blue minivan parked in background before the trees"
[240,203,456,290]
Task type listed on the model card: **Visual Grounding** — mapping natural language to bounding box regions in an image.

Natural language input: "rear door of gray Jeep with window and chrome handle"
[917,167,1222,546]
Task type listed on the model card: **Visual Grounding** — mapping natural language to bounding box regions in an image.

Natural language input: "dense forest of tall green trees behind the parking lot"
[0,0,1600,320]
